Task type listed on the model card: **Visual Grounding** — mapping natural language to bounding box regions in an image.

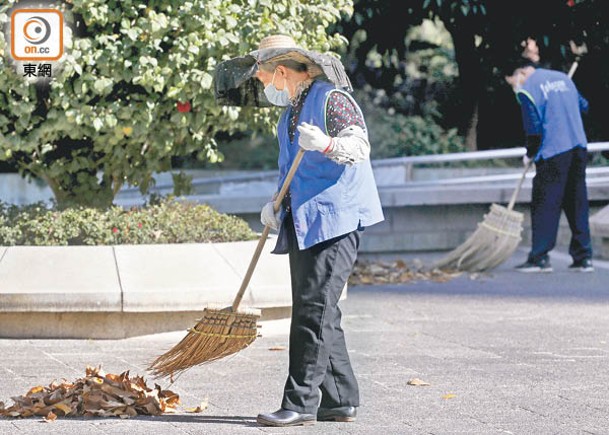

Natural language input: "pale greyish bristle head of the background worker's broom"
[432,204,524,272]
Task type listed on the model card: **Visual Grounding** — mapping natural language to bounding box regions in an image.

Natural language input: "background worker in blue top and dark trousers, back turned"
[505,58,594,272]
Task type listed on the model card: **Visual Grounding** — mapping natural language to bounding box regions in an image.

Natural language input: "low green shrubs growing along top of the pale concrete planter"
[0,199,256,246]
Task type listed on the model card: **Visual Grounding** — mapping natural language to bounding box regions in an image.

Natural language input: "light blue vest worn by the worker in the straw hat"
[274,81,384,254]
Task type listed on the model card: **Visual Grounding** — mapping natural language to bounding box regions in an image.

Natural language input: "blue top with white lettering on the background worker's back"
[517,68,588,160]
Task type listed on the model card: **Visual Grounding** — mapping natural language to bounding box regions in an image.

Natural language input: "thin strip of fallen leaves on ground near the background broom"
[349,260,460,285]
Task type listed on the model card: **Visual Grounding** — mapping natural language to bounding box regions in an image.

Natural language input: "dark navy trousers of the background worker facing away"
[529,147,592,262]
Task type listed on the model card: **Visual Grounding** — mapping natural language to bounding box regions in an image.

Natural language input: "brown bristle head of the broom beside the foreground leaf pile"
[148,308,260,378]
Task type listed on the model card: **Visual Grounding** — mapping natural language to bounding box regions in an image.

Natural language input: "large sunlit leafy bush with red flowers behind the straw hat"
[0,0,352,206]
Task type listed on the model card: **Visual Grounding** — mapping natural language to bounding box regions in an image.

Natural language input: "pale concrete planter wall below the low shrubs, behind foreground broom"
[0,237,298,338]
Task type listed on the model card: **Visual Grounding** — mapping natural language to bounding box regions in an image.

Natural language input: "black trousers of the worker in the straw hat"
[281,213,360,414]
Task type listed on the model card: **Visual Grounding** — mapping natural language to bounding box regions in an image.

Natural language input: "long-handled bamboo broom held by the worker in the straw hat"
[148,148,304,377]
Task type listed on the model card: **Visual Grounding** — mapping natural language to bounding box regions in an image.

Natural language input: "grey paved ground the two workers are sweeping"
[0,252,609,435]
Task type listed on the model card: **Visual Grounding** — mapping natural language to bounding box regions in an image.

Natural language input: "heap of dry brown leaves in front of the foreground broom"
[0,367,180,421]
